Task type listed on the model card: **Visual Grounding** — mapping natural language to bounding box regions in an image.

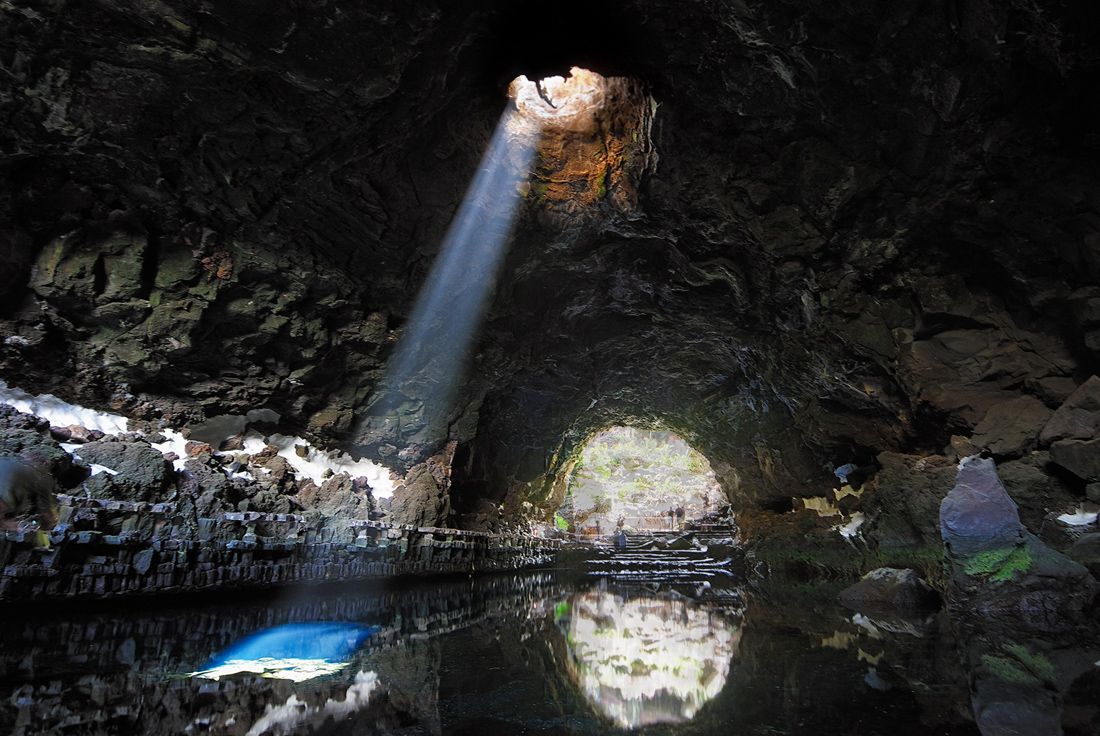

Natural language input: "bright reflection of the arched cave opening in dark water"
[559,590,740,728]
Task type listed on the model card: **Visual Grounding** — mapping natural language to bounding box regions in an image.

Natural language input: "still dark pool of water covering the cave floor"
[0,574,977,736]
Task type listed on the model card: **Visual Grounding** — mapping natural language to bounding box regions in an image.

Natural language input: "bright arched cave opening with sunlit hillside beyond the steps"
[558,426,724,534]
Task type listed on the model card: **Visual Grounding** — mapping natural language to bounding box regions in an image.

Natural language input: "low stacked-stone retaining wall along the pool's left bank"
[0,495,559,601]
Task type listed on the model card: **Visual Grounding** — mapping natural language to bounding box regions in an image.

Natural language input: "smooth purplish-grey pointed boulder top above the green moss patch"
[939,458,1023,556]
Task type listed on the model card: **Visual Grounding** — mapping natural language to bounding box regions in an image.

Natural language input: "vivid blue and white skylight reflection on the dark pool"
[194,622,378,682]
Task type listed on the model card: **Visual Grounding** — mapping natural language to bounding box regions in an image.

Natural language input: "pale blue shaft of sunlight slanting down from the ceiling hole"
[375,105,539,433]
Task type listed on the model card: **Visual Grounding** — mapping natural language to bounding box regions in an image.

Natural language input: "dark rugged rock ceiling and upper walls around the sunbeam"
[0,0,1100,525]
